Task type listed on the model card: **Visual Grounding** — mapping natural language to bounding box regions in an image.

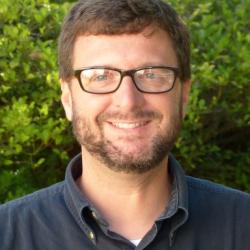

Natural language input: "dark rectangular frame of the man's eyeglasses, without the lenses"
[74,66,180,95]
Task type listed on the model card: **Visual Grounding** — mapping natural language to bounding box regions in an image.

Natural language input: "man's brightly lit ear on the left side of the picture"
[60,79,73,121]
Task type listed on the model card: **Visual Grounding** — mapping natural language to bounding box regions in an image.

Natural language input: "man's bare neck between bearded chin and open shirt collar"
[78,147,171,239]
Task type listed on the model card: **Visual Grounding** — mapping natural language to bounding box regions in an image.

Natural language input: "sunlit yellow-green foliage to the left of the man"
[0,0,74,201]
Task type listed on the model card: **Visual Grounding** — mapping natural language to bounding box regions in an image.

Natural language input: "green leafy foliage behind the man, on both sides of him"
[0,0,250,202]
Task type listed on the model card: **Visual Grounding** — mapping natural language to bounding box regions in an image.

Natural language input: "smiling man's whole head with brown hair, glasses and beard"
[59,0,190,173]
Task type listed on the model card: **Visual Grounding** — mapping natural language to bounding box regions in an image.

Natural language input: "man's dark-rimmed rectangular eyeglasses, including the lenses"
[74,66,179,94]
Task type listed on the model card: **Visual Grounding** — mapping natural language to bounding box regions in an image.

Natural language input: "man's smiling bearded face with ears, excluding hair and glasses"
[62,26,189,173]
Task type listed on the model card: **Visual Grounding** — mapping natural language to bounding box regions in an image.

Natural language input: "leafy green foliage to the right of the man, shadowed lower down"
[174,0,250,191]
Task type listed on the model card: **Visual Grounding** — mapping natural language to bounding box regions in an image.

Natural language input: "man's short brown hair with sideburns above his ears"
[59,0,191,81]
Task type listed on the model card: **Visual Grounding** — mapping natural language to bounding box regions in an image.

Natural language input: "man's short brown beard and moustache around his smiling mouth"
[72,105,182,173]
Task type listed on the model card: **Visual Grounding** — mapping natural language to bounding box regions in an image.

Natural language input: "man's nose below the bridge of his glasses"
[113,75,145,112]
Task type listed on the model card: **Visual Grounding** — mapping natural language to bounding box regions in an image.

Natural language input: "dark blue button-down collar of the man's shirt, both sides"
[65,154,188,244]
